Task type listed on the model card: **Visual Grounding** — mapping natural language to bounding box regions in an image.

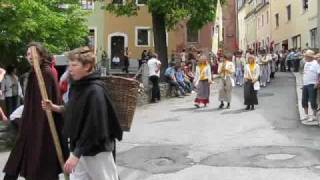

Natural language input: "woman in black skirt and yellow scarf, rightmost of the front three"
[244,55,260,110]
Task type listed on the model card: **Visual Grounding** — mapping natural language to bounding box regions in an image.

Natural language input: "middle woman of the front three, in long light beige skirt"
[218,55,235,109]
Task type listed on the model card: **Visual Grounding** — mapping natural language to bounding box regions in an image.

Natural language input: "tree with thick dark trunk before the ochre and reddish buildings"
[102,0,225,69]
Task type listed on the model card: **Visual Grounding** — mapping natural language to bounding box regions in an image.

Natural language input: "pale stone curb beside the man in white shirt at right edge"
[292,72,319,126]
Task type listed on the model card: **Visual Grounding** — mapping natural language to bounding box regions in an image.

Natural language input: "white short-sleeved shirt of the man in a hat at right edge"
[303,60,320,85]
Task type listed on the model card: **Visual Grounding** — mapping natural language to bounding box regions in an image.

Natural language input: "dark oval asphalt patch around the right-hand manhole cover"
[202,146,320,168]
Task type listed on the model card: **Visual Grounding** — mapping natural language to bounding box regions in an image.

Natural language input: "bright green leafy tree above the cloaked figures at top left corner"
[0,0,88,69]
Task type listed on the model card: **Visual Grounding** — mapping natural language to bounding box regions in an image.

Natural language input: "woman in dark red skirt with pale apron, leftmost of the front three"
[194,55,212,108]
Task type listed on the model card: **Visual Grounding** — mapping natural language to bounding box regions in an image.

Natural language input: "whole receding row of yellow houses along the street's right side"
[238,0,320,53]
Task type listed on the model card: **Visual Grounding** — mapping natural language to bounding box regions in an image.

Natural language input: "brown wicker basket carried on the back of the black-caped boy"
[103,76,139,131]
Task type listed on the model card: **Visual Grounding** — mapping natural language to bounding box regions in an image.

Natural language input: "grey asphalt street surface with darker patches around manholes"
[0,73,320,180]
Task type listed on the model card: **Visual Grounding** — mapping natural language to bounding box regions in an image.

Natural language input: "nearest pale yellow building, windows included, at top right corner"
[271,0,320,50]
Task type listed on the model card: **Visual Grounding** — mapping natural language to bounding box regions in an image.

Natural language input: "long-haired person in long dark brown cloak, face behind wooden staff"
[3,43,66,180]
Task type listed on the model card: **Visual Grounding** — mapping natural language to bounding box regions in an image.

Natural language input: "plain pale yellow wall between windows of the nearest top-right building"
[270,0,318,49]
